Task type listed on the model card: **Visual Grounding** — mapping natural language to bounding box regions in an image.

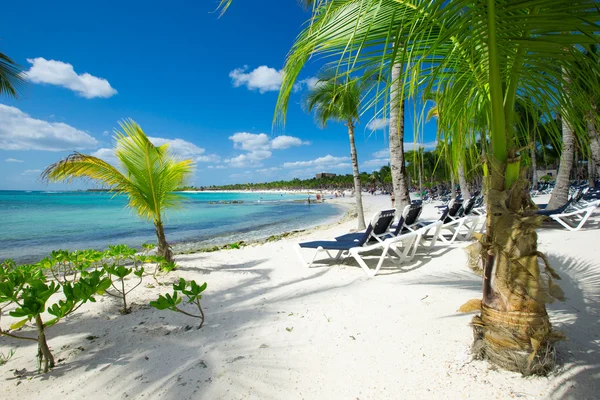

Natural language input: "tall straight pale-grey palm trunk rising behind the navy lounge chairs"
[390,64,410,215]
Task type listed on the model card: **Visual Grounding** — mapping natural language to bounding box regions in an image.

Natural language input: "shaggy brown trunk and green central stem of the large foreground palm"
[468,0,557,375]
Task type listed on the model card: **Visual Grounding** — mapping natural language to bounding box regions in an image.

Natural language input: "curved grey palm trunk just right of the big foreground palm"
[547,116,575,210]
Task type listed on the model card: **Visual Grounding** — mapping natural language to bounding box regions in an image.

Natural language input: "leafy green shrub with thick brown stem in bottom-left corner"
[0,261,111,373]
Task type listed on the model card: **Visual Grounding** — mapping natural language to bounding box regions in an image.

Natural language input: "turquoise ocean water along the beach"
[0,191,342,262]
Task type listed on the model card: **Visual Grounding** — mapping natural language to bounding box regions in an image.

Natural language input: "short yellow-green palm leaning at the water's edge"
[42,120,193,262]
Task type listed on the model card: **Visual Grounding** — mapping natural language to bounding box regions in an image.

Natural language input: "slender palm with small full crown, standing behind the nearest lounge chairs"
[306,77,366,230]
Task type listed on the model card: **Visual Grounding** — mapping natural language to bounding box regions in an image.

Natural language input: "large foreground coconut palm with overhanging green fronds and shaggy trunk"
[270,0,600,374]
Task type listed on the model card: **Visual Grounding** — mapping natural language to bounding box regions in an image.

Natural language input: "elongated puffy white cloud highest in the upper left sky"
[25,57,117,99]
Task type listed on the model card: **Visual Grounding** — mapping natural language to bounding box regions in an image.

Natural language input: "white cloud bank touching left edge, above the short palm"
[0,104,98,151]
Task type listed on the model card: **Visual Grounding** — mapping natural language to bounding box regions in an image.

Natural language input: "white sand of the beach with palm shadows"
[0,195,600,399]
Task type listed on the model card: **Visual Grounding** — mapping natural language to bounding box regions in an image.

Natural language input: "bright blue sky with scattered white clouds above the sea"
[0,0,435,190]
